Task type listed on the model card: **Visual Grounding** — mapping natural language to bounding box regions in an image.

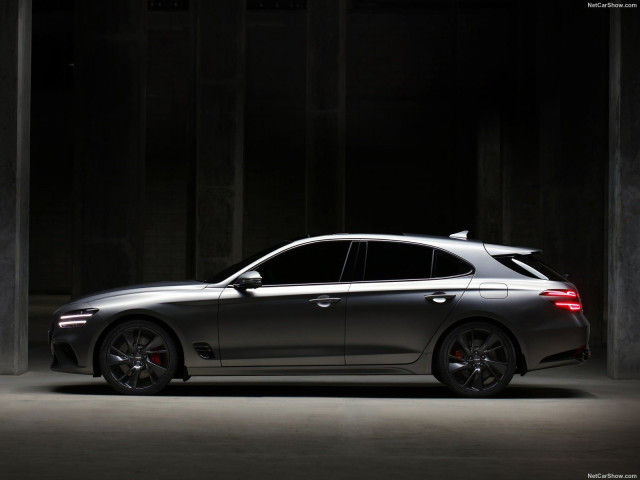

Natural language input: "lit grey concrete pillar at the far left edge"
[0,0,31,375]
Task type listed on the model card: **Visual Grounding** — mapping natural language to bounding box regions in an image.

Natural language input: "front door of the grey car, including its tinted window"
[218,241,351,367]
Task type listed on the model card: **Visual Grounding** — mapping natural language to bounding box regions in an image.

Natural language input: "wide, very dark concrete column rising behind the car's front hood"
[72,0,147,296]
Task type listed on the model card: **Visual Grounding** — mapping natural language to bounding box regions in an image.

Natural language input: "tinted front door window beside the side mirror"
[256,241,351,285]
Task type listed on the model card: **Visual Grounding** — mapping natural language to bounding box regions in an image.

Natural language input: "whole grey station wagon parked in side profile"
[49,232,590,397]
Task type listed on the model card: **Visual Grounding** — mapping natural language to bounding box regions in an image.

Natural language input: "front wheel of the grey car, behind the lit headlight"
[100,320,178,395]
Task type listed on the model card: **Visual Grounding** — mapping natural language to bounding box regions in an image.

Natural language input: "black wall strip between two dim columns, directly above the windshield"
[243,9,307,254]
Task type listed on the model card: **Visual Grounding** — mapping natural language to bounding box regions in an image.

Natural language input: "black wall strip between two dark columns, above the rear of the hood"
[142,6,195,282]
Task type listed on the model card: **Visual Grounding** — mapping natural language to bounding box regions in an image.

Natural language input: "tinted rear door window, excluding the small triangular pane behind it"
[364,242,433,280]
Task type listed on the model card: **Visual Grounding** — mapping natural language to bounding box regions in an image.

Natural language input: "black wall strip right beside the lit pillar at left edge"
[29,2,75,293]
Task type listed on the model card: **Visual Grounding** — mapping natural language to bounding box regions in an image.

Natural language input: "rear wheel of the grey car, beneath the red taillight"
[437,322,516,397]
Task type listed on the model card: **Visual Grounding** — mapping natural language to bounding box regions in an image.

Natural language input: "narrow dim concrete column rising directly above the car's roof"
[306,0,347,234]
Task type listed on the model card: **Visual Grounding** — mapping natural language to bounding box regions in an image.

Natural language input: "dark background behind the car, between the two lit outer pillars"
[30,0,609,344]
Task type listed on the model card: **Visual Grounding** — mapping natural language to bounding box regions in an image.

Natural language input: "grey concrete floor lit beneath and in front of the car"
[0,298,640,480]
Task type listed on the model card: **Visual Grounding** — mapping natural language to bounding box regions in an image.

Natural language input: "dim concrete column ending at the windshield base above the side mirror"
[195,0,245,278]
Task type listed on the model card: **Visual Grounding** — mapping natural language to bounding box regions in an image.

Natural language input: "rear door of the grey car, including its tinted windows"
[345,241,473,365]
